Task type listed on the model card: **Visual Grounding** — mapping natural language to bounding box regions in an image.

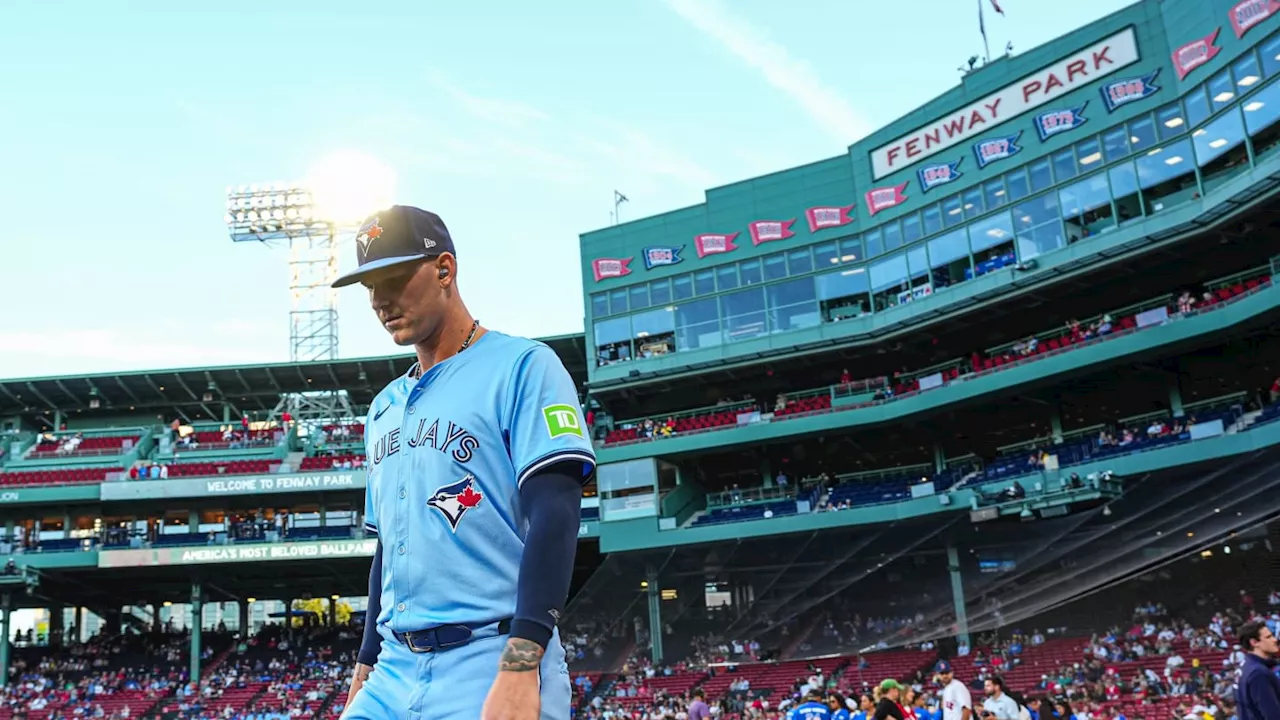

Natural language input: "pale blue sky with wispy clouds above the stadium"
[0,0,1125,377]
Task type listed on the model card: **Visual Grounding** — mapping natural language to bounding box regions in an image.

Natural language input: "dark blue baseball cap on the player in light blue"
[333,205,457,287]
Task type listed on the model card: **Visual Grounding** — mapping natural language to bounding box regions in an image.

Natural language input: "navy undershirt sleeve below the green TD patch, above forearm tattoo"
[511,461,582,647]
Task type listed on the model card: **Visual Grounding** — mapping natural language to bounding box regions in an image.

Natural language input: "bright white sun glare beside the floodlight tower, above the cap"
[306,150,396,223]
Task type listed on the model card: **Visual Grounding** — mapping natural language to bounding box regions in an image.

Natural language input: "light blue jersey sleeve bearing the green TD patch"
[503,343,595,487]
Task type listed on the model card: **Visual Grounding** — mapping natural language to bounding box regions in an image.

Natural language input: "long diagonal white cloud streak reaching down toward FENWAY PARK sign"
[663,0,869,145]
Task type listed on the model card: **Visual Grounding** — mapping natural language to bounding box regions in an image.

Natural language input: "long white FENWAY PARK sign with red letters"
[870,27,1139,181]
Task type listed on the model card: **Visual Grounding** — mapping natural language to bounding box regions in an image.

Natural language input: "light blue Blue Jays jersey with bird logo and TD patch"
[365,331,595,633]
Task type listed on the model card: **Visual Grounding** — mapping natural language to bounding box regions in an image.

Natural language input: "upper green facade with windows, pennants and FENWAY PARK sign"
[581,0,1280,387]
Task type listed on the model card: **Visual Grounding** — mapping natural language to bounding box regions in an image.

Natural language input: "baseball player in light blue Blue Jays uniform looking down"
[334,206,595,720]
